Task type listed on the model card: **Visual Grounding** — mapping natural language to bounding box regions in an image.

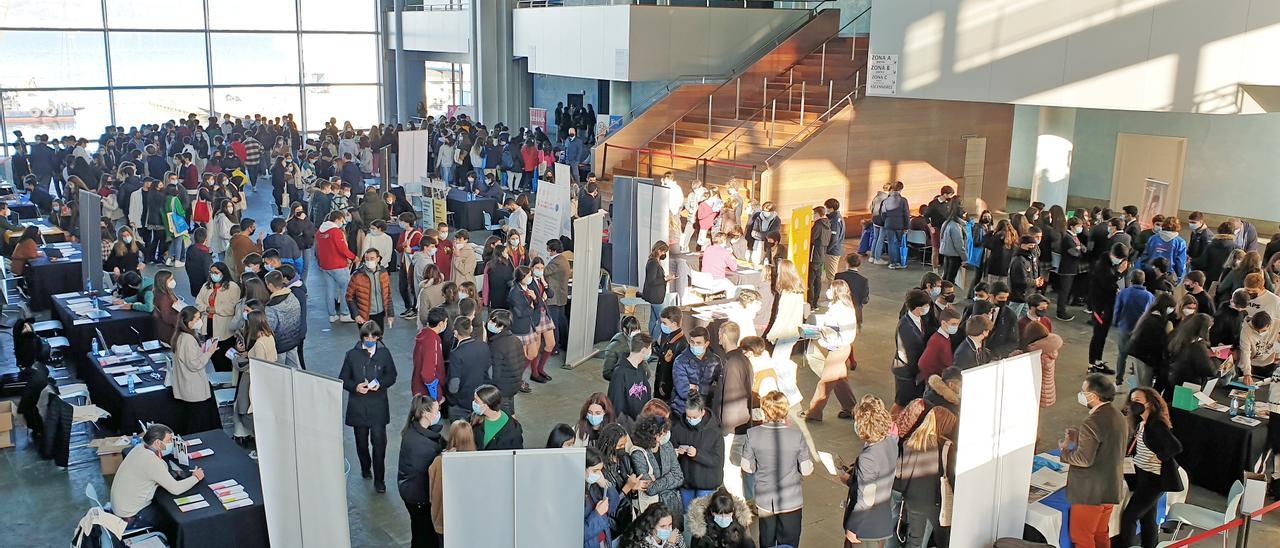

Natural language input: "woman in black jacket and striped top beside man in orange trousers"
[1119,388,1185,548]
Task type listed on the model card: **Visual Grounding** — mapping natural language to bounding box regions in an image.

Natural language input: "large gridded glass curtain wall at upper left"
[0,0,381,174]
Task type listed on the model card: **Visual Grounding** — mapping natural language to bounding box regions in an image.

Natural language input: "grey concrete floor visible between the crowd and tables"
[0,184,1280,547]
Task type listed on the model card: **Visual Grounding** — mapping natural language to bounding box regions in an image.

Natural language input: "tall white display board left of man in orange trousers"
[951,352,1039,545]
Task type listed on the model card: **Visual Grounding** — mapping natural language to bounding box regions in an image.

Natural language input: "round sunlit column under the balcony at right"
[1032,106,1075,209]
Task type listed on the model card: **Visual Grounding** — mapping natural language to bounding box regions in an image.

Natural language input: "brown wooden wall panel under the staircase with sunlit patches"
[767,97,1014,226]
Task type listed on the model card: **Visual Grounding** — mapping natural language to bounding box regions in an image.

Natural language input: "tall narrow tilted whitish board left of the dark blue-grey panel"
[564,211,604,366]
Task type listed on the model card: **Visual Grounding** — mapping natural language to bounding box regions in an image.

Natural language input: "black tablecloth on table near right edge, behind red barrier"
[1169,388,1268,494]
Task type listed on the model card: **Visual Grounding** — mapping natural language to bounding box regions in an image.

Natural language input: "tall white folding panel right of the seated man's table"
[250,360,351,548]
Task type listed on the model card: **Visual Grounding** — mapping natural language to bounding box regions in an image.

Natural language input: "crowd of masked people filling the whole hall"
[10,113,1280,548]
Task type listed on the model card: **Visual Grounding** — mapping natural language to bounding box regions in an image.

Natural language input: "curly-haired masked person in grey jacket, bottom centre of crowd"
[631,415,691,522]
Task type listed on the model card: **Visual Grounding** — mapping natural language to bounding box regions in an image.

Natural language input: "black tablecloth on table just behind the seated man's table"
[78,351,198,434]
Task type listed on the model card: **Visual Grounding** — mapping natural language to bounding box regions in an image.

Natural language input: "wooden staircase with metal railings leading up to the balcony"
[602,5,869,189]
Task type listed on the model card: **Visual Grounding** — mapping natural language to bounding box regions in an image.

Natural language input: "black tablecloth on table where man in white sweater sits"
[155,430,270,548]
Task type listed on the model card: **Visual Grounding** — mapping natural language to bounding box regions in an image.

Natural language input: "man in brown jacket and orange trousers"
[1057,373,1129,548]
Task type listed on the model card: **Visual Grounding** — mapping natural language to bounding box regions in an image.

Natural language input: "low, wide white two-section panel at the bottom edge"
[442,448,586,548]
